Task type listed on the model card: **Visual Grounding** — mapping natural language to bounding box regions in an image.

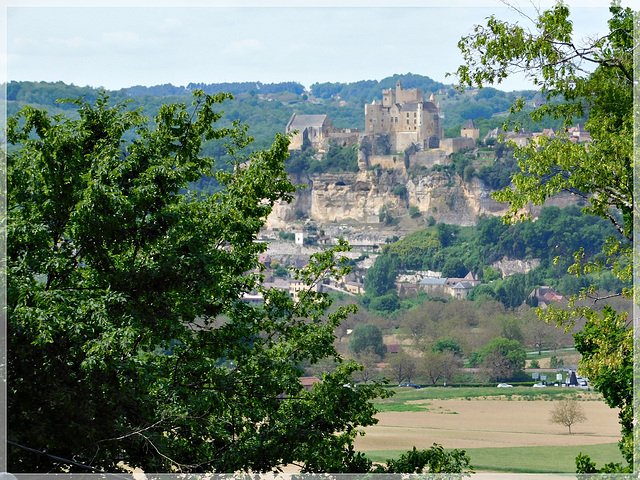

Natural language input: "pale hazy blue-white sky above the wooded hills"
[0,0,629,94]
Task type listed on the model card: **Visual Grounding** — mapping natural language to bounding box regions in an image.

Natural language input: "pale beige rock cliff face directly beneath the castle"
[267,169,506,229]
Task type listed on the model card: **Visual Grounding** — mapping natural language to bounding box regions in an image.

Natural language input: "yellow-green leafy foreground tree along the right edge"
[457,2,639,473]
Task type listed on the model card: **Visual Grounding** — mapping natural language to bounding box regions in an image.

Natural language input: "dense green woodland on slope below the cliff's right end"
[364,206,625,312]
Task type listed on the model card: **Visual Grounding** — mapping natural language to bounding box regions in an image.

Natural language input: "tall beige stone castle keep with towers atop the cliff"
[364,80,444,152]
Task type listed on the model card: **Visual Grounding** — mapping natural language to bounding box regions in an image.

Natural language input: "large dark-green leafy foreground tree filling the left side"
[7,92,384,472]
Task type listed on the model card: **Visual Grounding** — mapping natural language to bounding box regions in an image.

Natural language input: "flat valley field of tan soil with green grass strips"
[356,387,622,473]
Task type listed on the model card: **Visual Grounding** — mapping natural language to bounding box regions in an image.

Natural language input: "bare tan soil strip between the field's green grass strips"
[355,399,620,451]
